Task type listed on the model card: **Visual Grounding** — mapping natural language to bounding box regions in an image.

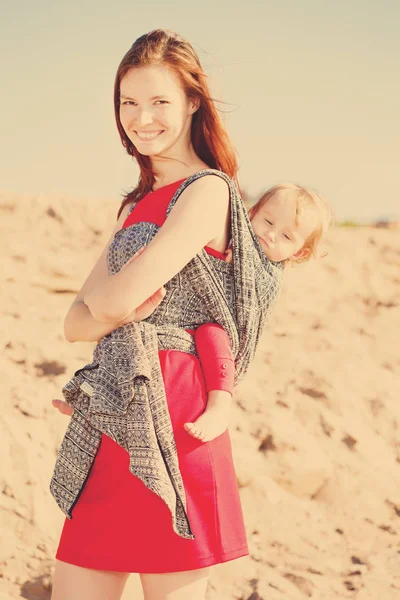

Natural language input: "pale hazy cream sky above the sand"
[0,0,400,222]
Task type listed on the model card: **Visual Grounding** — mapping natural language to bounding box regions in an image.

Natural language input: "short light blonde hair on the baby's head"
[249,183,333,263]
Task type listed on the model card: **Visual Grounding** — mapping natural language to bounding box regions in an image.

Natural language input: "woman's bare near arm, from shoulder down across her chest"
[83,175,229,323]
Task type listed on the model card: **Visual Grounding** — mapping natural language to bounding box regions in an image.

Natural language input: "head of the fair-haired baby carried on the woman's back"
[249,183,332,263]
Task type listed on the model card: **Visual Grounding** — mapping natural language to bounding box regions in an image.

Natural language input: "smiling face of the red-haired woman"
[119,65,197,158]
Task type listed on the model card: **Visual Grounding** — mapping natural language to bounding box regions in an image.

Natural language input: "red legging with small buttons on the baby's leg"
[194,323,235,394]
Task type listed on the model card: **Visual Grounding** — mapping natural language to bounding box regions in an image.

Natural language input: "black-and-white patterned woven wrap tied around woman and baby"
[50,169,282,539]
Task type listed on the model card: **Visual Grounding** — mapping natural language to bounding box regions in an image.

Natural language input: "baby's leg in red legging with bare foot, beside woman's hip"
[185,323,235,442]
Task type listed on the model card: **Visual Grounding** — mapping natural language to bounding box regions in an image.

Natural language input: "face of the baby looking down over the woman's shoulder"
[251,192,316,262]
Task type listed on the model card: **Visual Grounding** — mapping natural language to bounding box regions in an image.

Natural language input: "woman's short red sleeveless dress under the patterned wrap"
[56,181,248,573]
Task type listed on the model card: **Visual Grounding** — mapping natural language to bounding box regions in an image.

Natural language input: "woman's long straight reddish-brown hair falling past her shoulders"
[114,29,238,217]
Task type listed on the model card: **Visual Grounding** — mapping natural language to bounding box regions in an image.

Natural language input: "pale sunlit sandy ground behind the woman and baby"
[0,194,400,600]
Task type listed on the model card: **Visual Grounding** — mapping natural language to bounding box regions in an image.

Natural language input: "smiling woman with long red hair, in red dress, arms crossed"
[52,30,248,600]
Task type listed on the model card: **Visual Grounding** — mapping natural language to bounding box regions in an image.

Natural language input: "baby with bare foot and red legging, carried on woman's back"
[184,184,332,442]
